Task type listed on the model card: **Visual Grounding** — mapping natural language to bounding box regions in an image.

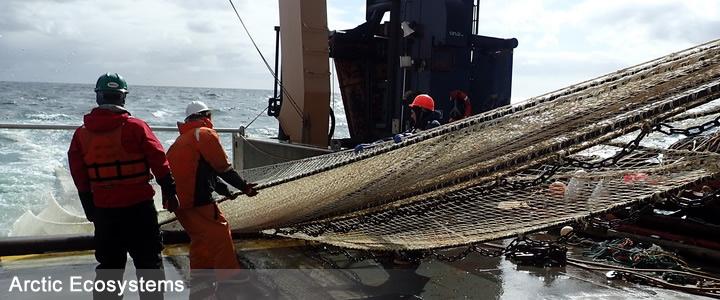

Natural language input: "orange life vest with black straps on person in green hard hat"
[78,123,152,191]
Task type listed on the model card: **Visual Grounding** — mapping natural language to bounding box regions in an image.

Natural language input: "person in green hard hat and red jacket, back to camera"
[68,73,178,299]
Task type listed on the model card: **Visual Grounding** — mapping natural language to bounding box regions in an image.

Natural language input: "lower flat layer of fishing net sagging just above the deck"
[280,150,720,250]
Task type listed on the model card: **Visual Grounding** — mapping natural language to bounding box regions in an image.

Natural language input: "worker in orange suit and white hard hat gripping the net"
[167,101,257,269]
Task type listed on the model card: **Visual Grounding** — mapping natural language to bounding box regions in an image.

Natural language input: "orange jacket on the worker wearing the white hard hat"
[167,118,245,209]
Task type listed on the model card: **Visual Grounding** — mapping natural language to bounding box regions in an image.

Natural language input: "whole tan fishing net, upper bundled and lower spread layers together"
[166,41,720,249]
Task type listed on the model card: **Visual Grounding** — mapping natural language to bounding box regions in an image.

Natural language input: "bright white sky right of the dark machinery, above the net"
[480,0,720,101]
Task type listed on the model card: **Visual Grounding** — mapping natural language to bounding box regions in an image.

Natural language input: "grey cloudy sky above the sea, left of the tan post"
[0,0,282,88]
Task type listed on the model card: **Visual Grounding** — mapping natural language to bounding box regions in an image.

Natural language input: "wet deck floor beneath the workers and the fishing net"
[0,241,703,300]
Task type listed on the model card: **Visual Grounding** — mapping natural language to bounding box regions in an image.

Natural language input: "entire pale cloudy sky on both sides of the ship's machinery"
[0,0,720,102]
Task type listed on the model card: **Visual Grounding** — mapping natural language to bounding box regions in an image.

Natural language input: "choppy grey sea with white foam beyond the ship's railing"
[0,82,348,237]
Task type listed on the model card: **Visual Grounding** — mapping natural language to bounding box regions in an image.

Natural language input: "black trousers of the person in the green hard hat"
[93,200,165,299]
